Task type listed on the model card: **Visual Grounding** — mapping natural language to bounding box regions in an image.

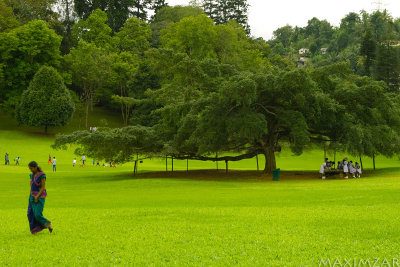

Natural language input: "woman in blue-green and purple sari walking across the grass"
[28,161,53,234]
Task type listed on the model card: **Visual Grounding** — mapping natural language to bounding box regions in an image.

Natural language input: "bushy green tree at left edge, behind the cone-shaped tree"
[0,20,61,102]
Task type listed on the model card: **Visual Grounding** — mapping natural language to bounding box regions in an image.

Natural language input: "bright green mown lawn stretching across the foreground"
[0,110,400,266]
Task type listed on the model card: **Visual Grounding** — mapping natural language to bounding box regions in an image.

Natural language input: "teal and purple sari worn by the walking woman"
[28,172,50,234]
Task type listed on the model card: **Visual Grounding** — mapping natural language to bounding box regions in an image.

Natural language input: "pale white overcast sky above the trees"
[167,0,400,40]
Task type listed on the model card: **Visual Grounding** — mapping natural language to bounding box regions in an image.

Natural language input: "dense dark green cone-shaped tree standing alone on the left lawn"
[16,66,75,133]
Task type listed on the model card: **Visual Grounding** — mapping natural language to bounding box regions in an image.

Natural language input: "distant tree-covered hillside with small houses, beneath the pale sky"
[268,10,400,92]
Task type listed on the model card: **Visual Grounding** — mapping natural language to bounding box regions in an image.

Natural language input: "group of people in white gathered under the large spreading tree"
[319,158,362,179]
